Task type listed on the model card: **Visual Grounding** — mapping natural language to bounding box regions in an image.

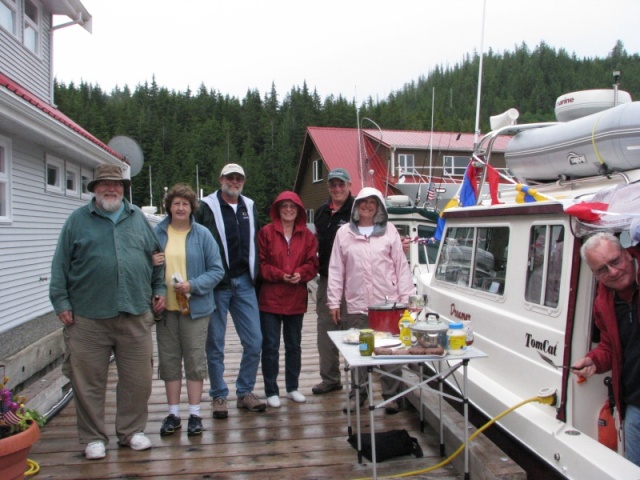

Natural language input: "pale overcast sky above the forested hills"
[54,0,640,102]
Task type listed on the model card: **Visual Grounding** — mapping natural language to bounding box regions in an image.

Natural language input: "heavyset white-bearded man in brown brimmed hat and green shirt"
[49,165,166,460]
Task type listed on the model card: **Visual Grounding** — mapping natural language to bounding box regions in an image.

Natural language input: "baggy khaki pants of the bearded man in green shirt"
[64,312,154,445]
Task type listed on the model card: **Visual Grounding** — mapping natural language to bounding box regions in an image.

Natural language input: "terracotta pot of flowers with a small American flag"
[0,377,44,480]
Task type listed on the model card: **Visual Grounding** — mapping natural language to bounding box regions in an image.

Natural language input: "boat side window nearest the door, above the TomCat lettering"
[525,225,564,308]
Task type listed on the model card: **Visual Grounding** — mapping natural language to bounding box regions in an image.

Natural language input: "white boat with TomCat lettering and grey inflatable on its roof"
[418,95,640,480]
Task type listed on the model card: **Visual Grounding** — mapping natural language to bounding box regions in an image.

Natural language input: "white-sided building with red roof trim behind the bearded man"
[0,0,130,411]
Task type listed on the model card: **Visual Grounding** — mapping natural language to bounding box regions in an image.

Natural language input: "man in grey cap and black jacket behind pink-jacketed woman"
[311,168,353,395]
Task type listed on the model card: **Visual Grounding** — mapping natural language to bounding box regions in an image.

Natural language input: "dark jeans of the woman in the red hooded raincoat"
[260,312,304,397]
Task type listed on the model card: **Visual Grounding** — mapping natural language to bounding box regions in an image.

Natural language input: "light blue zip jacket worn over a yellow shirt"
[156,217,224,318]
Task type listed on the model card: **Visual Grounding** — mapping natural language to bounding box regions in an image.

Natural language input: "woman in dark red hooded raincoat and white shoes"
[258,191,318,408]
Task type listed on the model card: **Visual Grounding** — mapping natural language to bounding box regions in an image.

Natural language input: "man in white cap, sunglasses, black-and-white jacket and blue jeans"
[195,163,267,419]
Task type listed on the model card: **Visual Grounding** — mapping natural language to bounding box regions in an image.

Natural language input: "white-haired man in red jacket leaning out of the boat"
[573,232,640,466]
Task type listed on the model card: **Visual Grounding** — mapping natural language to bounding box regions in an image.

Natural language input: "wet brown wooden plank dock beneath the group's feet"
[30,305,484,480]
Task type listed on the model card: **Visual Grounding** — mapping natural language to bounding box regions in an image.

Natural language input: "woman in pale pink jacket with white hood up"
[327,187,415,413]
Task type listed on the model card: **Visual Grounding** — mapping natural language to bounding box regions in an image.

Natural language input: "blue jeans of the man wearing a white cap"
[207,274,262,398]
